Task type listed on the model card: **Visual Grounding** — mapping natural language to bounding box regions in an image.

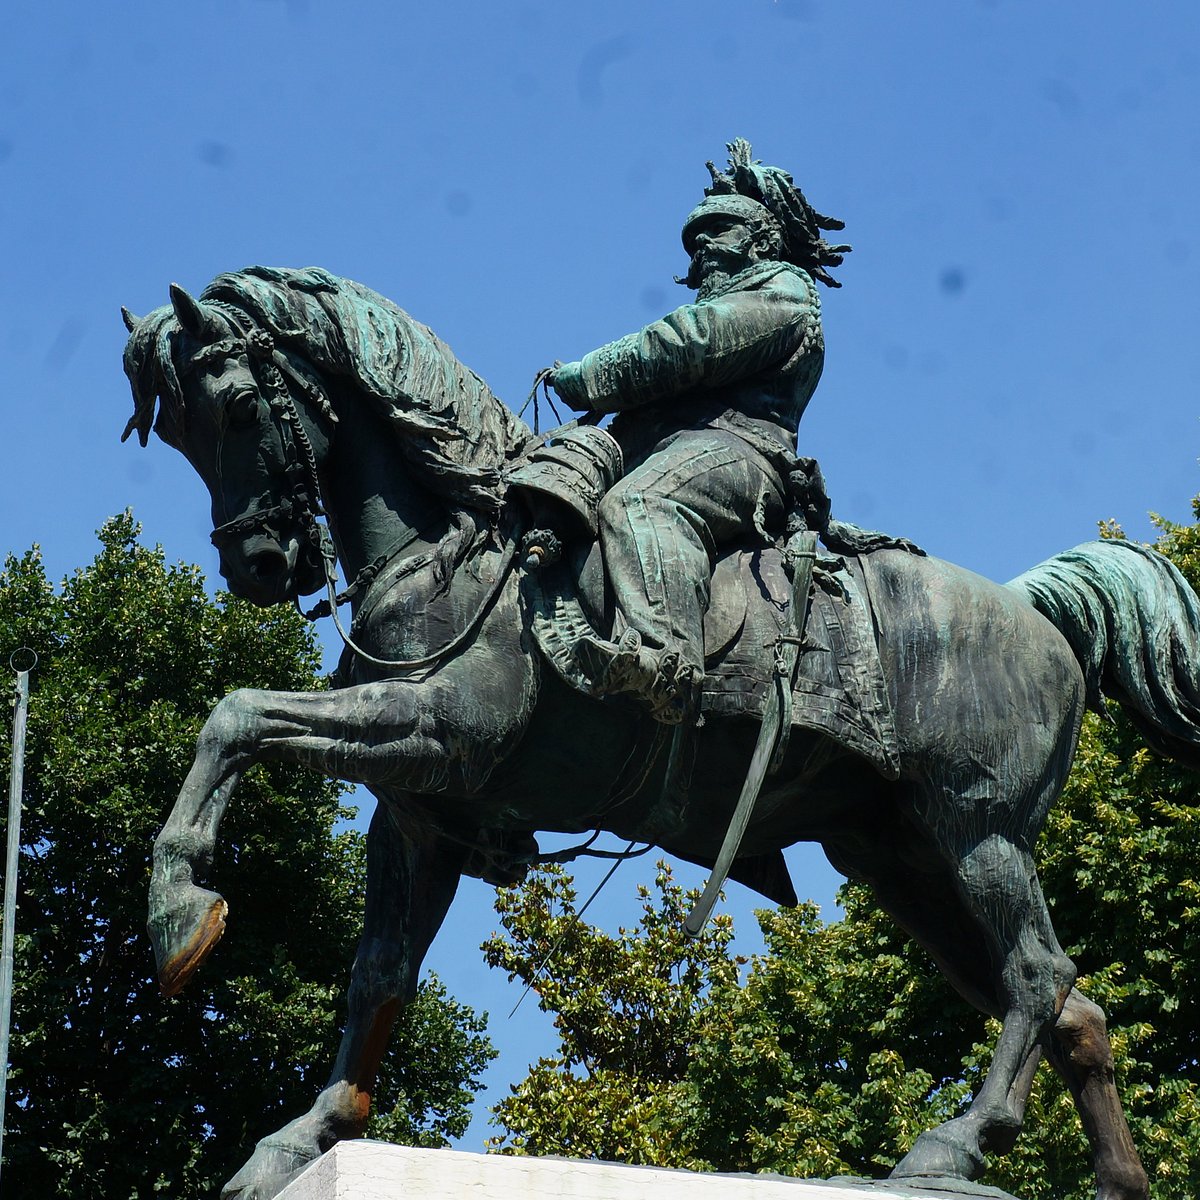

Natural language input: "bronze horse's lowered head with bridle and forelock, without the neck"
[125,284,336,606]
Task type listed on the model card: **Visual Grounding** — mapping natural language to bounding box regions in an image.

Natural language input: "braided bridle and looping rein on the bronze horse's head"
[192,314,517,671]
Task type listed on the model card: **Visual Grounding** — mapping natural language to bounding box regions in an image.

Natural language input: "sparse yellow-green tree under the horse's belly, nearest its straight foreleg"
[484,864,739,1164]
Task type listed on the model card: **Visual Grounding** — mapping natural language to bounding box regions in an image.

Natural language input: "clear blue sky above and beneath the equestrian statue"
[0,0,1200,1148]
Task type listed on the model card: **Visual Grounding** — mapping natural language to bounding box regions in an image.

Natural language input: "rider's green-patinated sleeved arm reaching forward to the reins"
[553,270,820,413]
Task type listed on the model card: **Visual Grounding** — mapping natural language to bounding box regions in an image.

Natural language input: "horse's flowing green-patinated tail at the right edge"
[1008,541,1200,770]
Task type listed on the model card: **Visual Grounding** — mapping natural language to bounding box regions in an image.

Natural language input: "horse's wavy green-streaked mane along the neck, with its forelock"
[125,266,529,511]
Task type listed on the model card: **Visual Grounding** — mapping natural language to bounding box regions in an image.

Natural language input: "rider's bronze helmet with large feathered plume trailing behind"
[683,138,851,288]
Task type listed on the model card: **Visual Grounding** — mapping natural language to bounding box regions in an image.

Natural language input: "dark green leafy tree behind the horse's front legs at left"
[0,514,493,1200]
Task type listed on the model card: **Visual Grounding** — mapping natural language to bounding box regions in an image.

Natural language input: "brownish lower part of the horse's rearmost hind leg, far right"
[1046,988,1150,1200]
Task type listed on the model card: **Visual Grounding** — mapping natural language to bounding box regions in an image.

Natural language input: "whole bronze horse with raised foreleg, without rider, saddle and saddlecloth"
[125,268,1200,1200]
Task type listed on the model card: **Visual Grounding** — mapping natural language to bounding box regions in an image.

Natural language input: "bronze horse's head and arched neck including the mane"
[125,266,529,605]
